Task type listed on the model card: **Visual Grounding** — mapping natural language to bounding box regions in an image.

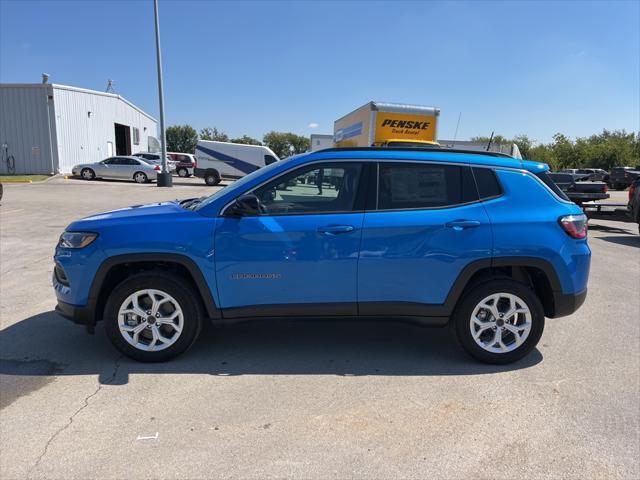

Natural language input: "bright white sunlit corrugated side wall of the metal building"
[53,85,156,173]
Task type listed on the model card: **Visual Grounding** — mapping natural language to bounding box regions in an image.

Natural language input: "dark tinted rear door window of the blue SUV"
[378,163,478,210]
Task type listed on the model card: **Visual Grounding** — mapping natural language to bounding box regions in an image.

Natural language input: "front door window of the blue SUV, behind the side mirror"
[254,163,362,215]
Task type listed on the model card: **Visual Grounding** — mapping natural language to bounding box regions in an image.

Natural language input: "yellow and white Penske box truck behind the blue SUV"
[333,102,440,147]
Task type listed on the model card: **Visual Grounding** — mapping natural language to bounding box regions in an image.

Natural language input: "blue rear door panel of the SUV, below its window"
[358,202,492,304]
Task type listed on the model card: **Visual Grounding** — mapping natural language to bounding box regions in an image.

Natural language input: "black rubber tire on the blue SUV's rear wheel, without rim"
[451,278,544,365]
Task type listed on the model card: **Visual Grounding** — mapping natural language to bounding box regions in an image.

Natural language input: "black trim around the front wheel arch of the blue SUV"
[87,253,220,324]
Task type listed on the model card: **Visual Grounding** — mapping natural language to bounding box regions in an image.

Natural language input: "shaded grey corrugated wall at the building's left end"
[0,84,57,174]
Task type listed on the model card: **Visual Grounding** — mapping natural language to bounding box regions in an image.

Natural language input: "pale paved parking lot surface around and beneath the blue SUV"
[0,178,640,479]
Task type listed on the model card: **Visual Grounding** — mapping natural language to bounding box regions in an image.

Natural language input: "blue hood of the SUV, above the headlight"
[67,201,195,232]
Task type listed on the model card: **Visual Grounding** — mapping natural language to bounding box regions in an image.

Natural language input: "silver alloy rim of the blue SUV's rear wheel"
[469,293,531,353]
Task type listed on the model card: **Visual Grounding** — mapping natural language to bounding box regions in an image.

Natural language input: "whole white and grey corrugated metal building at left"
[0,83,157,174]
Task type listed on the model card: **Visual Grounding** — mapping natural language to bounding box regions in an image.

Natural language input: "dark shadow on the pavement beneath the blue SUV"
[0,311,542,395]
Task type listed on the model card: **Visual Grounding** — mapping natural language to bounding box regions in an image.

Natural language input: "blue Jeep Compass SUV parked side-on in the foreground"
[53,148,591,363]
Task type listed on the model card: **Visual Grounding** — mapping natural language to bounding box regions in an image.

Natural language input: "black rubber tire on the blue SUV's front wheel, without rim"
[104,271,203,362]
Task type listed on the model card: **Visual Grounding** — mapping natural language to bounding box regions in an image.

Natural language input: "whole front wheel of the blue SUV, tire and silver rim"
[104,272,202,362]
